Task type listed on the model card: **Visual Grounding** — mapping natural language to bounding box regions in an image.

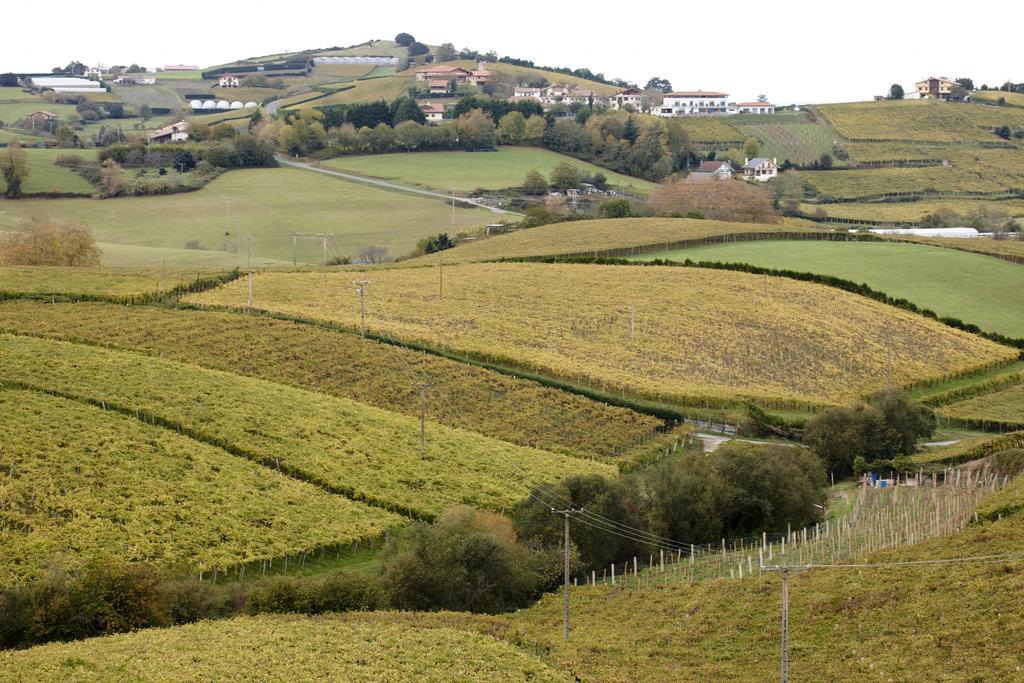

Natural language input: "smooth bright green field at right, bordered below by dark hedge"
[638,241,1024,337]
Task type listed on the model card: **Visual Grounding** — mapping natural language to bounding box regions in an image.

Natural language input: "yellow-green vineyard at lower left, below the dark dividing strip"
[0,390,402,588]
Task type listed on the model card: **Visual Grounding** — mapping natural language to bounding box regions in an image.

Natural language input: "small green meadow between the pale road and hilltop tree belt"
[324,146,657,193]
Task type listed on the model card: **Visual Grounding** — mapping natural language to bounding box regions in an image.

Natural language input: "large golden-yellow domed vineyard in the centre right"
[189,263,1017,408]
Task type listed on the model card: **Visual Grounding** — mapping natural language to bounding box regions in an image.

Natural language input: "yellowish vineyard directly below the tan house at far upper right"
[816,99,1024,142]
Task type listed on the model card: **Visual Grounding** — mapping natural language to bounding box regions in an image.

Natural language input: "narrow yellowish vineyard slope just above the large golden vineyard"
[411,218,823,264]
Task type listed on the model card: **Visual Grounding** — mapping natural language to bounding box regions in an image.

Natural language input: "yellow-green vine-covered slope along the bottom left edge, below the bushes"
[0,615,571,683]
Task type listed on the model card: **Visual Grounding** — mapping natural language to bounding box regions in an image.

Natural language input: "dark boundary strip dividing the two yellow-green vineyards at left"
[0,374,435,521]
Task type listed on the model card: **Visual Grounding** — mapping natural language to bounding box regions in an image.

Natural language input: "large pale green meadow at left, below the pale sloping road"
[0,166,494,263]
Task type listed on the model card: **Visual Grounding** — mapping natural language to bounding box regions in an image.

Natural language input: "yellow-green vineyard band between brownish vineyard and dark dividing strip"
[0,335,615,517]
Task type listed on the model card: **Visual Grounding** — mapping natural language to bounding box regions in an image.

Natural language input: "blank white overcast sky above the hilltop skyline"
[6,0,1024,104]
